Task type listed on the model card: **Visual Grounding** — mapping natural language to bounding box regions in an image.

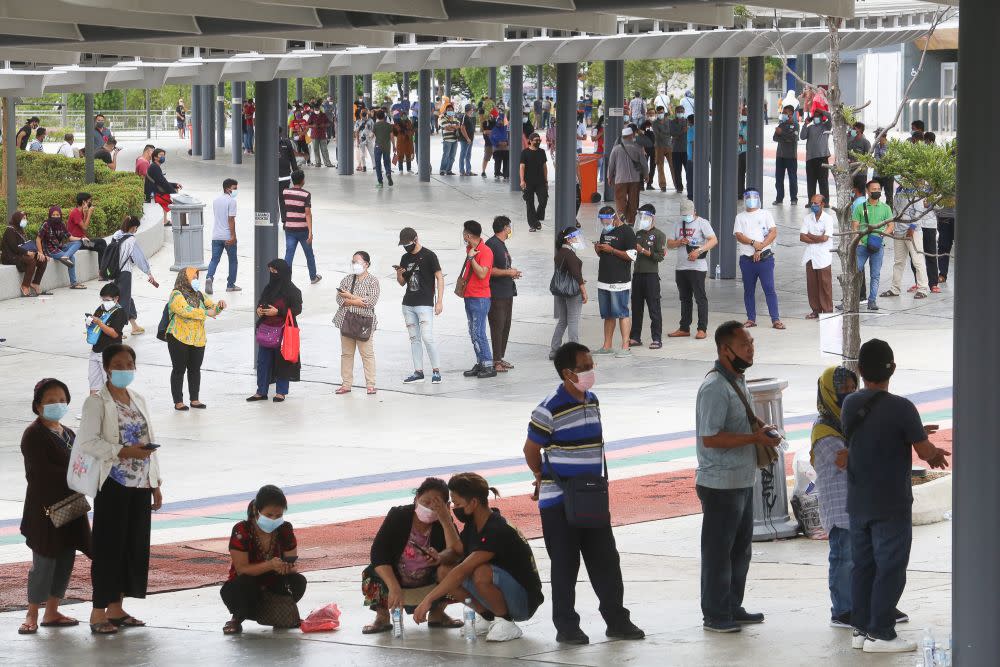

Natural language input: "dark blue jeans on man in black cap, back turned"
[851,512,913,640]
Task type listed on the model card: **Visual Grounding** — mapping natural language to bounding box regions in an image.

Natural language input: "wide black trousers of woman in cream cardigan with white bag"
[90,477,153,609]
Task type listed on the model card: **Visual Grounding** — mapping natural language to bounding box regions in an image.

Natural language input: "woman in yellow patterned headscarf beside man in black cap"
[809,366,858,628]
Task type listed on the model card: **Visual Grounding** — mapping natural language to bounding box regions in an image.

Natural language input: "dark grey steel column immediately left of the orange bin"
[556,63,579,235]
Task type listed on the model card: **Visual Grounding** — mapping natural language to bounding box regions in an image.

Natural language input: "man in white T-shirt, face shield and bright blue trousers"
[733,190,785,329]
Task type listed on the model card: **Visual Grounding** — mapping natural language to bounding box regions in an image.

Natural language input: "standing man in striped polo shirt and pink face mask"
[524,343,646,644]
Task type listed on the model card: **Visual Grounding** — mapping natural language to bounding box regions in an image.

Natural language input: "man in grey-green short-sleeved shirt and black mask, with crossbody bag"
[695,321,781,632]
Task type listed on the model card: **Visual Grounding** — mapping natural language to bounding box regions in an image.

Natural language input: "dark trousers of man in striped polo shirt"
[539,504,630,632]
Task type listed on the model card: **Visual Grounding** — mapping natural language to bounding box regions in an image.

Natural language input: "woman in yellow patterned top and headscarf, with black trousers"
[167,266,226,411]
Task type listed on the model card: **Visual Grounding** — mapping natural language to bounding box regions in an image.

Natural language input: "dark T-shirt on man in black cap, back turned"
[841,389,927,520]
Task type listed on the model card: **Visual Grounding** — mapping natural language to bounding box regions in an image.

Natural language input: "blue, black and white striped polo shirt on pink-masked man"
[528,385,604,508]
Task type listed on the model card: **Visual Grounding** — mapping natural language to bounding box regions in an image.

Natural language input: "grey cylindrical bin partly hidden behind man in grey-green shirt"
[747,378,799,542]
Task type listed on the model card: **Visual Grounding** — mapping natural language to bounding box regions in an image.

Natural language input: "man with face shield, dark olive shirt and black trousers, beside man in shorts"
[629,204,667,350]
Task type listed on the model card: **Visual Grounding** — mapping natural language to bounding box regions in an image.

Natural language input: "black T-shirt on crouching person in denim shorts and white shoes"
[461,509,545,614]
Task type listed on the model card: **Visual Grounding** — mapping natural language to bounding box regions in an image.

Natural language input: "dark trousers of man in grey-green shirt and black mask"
[695,485,753,622]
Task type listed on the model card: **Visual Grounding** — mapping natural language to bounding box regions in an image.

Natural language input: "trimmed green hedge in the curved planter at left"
[0,151,143,237]
